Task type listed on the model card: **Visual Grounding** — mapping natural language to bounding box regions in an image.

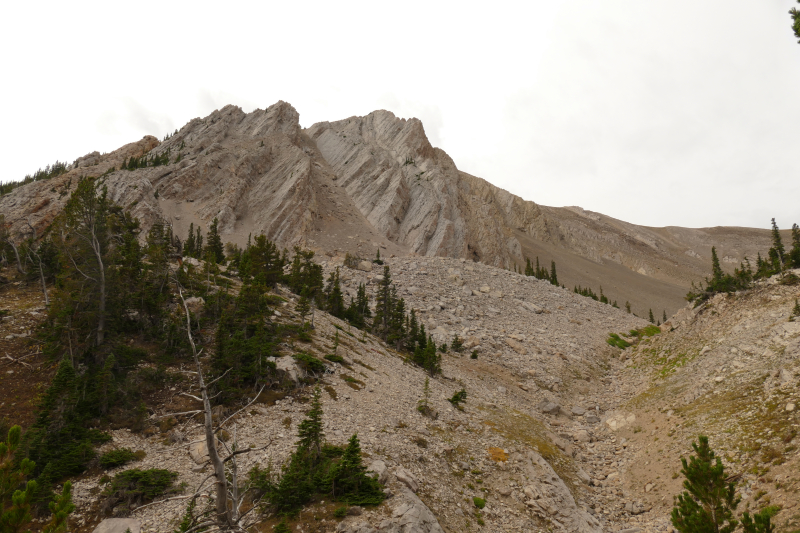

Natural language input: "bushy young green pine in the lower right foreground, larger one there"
[672,435,741,533]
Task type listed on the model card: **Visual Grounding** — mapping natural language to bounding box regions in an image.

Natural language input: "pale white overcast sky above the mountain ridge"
[0,0,800,228]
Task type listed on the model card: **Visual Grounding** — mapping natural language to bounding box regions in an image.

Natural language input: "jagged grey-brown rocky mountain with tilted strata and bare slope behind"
[0,102,780,315]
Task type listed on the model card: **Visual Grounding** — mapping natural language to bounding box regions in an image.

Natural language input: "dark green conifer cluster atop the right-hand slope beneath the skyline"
[686,218,800,306]
